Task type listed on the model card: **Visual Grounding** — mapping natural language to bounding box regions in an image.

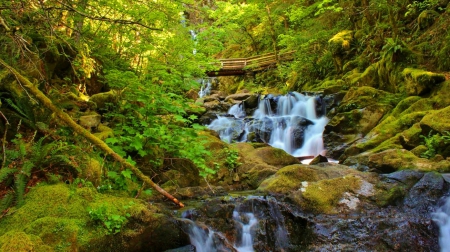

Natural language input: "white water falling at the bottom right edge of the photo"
[432,197,450,252]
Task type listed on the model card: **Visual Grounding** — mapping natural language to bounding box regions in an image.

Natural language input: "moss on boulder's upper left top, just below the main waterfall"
[258,165,319,193]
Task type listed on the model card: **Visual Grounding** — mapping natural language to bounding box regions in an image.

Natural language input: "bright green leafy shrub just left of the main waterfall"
[106,72,214,176]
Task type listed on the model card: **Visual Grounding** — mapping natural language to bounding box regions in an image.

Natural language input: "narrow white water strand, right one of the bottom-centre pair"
[233,211,258,252]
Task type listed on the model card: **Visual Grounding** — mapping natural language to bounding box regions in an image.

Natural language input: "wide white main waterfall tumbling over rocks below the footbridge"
[208,92,328,157]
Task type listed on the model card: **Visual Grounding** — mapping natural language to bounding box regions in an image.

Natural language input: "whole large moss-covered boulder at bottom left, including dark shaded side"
[0,184,187,251]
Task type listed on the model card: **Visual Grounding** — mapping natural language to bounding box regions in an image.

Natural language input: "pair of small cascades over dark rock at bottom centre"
[181,196,296,252]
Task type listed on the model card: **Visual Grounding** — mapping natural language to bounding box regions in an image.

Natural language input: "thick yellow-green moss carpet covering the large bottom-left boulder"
[0,184,156,251]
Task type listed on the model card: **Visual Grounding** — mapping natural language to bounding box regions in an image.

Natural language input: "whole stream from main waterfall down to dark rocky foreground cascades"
[171,90,450,252]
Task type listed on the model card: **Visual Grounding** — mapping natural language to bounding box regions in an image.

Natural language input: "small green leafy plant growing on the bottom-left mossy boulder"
[89,201,134,234]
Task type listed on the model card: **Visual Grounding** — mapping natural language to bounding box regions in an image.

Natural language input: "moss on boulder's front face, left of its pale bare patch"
[302,176,362,213]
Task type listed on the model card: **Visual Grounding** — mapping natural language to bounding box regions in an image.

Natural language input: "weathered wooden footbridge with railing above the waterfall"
[206,51,295,77]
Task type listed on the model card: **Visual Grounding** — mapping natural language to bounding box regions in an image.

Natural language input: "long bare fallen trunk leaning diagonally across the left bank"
[0,59,184,207]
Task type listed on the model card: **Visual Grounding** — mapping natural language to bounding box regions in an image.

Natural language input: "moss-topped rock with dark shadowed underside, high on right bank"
[402,68,445,95]
